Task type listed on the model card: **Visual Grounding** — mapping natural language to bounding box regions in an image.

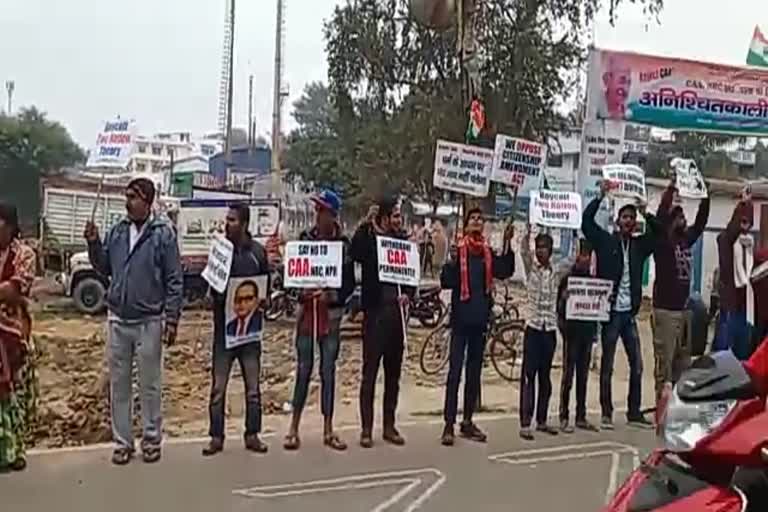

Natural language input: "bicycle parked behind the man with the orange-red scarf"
[419,305,525,382]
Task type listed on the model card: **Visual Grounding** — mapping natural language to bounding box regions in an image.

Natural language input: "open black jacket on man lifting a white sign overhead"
[581,197,659,315]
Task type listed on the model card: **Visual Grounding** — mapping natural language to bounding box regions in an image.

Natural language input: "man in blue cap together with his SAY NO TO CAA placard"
[283,190,355,451]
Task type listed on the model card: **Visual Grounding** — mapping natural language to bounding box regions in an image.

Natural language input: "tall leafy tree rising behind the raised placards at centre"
[314,0,662,202]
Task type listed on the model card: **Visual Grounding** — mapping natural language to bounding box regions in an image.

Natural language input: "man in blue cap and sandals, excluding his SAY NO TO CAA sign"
[283,190,355,451]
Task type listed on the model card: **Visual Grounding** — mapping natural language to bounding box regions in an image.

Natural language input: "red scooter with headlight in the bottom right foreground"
[603,340,768,512]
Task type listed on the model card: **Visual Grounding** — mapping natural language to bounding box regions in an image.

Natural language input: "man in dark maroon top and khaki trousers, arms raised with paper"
[651,181,709,401]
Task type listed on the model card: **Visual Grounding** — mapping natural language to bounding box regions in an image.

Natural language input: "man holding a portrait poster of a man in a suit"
[203,204,269,456]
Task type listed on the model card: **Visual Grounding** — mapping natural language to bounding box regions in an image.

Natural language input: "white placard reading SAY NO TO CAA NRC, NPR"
[283,241,342,288]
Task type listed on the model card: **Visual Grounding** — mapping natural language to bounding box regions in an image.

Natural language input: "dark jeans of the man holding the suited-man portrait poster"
[208,336,261,439]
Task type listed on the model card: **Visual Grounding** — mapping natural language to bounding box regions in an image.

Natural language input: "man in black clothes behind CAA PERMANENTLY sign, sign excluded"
[351,197,415,448]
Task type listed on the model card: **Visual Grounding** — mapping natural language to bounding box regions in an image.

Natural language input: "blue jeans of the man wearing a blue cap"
[293,320,341,418]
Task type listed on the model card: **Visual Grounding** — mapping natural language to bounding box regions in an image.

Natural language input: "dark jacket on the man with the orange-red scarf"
[440,247,515,331]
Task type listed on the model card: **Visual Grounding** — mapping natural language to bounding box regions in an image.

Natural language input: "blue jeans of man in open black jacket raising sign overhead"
[600,311,643,419]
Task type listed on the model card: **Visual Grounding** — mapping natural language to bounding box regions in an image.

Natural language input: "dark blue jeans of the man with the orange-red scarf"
[443,328,485,425]
